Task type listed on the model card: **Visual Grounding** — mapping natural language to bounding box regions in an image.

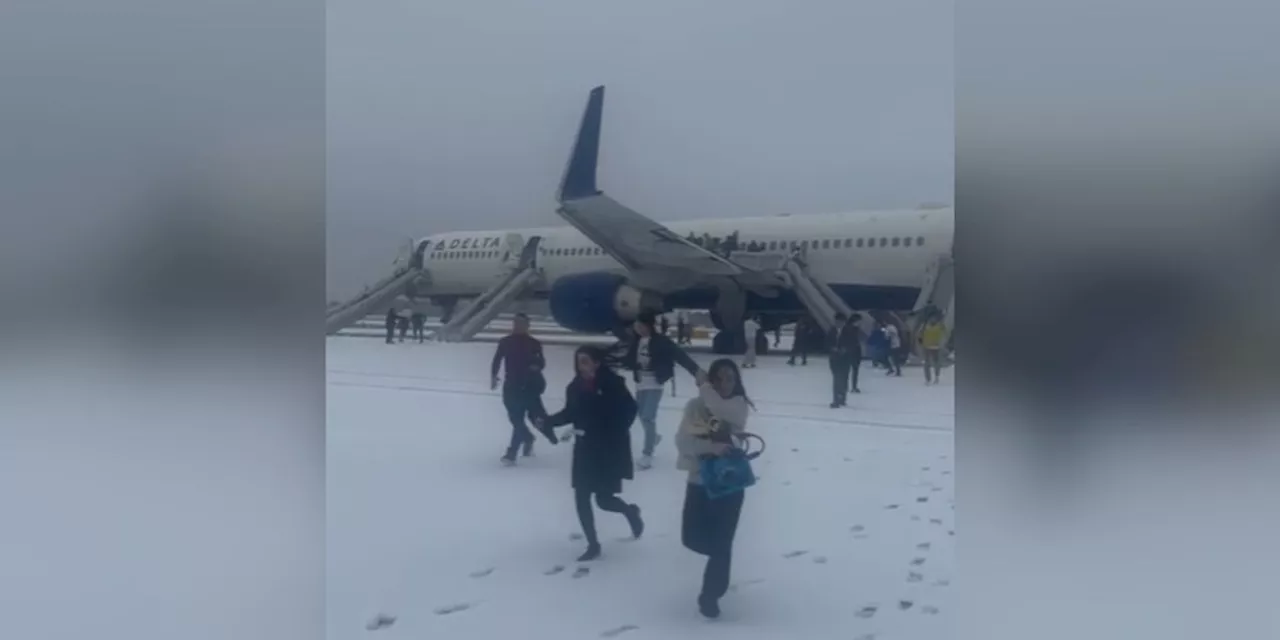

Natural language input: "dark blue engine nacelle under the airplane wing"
[549,271,662,333]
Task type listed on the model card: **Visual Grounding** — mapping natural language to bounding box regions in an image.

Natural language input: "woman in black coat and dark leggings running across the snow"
[544,347,644,562]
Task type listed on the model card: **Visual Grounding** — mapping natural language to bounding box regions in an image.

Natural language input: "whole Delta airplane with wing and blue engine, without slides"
[417,87,955,353]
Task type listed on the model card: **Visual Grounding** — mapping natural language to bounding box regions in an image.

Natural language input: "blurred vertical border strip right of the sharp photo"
[956,0,1280,640]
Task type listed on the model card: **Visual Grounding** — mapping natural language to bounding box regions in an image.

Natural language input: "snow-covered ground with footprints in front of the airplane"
[326,338,956,640]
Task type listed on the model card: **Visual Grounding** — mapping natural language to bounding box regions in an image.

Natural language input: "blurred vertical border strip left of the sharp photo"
[0,0,325,640]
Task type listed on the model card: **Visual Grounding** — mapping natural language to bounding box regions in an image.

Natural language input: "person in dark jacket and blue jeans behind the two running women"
[622,311,707,468]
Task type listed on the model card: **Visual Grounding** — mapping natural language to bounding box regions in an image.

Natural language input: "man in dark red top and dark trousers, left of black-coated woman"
[489,314,556,466]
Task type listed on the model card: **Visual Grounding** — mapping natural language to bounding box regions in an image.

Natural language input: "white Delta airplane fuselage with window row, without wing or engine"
[420,207,955,320]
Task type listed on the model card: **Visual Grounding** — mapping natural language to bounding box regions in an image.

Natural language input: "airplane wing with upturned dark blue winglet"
[557,86,745,275]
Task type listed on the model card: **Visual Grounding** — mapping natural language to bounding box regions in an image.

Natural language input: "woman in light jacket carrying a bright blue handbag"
[676,360,763,618]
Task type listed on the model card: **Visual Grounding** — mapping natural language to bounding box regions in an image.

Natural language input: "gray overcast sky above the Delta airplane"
[328,0,955,296]
